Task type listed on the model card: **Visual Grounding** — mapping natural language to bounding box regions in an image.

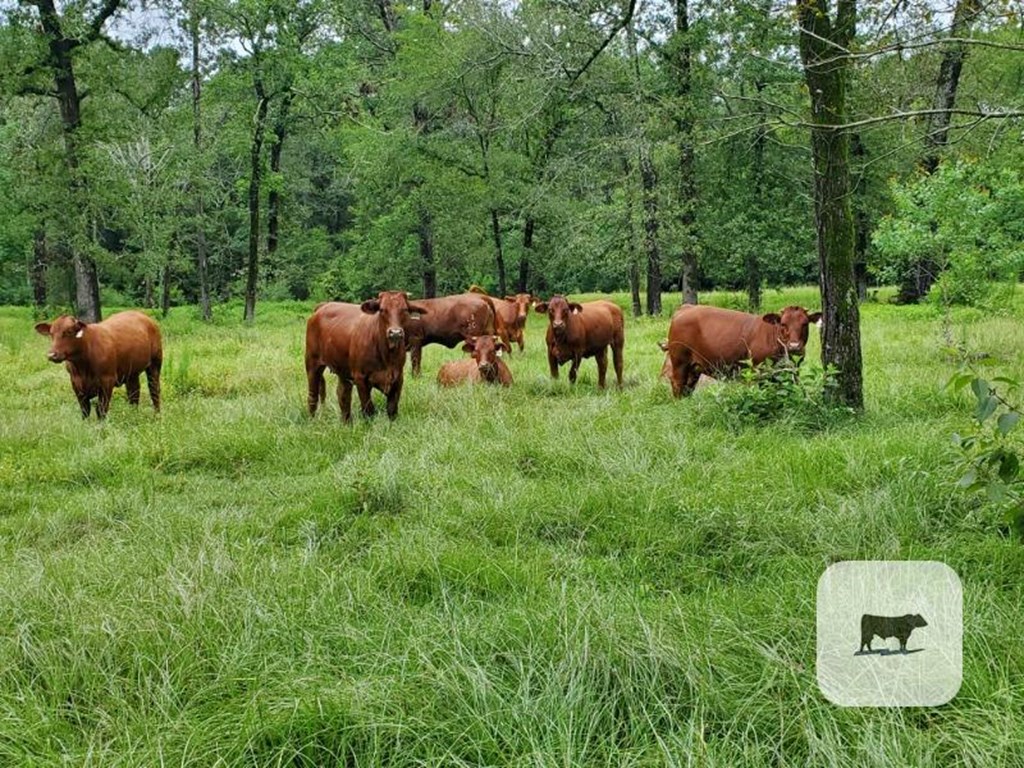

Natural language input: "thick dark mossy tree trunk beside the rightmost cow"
[797,0,864,409]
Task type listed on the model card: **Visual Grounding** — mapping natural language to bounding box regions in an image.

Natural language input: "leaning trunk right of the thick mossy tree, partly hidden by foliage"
[896,0,981,304]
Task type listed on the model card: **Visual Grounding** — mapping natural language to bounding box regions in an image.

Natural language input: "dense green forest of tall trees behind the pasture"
[0,0,1024,317]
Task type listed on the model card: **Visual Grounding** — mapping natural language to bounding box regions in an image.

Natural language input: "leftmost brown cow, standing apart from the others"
[36,311,164,419]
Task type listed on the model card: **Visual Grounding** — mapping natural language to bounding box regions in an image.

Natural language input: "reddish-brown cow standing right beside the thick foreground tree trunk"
[669,304,821,397]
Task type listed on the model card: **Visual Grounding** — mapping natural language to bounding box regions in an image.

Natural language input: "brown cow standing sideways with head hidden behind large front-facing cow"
[409,293,498,376]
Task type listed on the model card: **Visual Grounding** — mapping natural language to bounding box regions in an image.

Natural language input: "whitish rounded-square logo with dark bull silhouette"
[817,560,964,707]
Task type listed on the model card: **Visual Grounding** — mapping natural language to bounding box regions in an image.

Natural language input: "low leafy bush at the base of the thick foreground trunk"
[715,358,853,431]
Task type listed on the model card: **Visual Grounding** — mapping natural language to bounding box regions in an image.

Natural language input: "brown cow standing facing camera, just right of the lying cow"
[534,296,626,389]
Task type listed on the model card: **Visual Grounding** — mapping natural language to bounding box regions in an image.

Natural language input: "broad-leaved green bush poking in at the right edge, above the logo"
[949,371,1024,537]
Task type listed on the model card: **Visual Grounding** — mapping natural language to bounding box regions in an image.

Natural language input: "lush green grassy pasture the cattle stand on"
[0,289,1024,768]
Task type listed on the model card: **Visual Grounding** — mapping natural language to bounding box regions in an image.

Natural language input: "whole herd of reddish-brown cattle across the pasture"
[36,286,821,421]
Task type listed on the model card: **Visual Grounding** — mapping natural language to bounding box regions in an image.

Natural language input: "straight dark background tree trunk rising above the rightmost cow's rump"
[672,0,697,304]
